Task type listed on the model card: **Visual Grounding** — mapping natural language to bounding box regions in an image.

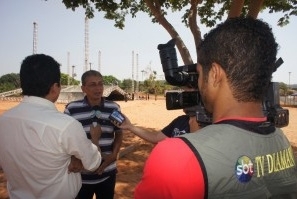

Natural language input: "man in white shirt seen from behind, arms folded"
[0,54,101,199]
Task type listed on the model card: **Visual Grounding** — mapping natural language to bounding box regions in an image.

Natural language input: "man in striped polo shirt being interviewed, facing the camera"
[64,70,123,199]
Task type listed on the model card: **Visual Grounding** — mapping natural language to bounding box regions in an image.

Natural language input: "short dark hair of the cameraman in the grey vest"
[197,17,278,102]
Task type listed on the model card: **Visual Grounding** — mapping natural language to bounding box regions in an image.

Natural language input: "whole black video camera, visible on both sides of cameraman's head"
[158,39,289,128]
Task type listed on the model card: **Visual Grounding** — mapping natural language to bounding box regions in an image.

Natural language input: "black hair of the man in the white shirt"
[20,54,61,97]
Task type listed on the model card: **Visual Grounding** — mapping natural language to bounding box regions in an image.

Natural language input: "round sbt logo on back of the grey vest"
[235,156,254,182]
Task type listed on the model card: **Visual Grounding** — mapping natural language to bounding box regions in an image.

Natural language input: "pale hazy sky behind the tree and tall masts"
[0,0,297,84]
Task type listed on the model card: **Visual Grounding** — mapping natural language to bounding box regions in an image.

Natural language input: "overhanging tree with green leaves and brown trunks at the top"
[62,0,297,64]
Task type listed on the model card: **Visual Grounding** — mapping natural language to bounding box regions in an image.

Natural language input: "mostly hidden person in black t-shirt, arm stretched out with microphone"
[115,106,203,144]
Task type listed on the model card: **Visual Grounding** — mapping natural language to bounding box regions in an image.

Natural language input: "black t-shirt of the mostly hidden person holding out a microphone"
[161,115,190,137]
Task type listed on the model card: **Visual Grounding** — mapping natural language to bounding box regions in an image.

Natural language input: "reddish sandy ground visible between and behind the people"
[0,99,297,199]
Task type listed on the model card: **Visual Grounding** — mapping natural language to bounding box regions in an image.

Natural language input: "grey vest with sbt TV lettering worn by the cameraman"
[182,124,297,199]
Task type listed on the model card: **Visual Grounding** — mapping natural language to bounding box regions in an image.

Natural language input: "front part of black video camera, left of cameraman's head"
[158,39,212,125]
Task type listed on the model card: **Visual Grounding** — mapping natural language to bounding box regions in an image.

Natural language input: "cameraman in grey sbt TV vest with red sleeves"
[134,18,297,199]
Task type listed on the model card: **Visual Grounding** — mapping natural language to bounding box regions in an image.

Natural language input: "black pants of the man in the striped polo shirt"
[76,174,116,199]
